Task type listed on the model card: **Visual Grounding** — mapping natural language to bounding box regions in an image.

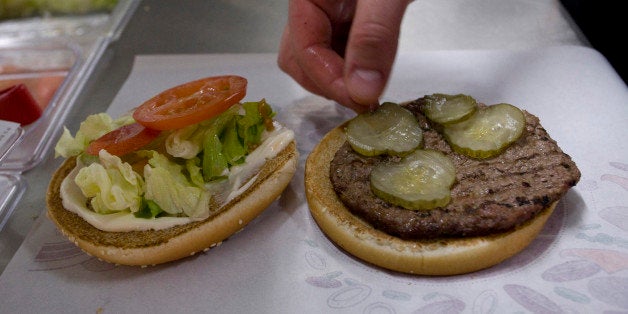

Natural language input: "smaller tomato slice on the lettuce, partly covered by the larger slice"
[85,123,161,156]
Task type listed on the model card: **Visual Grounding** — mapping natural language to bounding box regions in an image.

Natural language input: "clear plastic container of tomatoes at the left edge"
[0,42,84,172]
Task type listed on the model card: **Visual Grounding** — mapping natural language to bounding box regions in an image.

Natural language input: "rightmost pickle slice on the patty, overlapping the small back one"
[443,104,525,159]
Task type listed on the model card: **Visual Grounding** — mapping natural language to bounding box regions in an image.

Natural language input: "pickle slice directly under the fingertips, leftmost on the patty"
[346,102,423,156]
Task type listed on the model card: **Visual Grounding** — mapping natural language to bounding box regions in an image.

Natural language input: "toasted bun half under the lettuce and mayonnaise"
[47,141,299,266]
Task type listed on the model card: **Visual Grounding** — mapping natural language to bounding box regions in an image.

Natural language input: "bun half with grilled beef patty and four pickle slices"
[305,94,580,275]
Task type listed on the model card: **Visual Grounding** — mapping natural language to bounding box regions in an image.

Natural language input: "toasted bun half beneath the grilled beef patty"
[305,126,556,275]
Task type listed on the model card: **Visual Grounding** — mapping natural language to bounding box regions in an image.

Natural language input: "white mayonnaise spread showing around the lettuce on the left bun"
[60,123,294,232]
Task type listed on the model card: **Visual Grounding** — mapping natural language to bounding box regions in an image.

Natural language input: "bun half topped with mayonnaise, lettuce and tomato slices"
[47,76,298,266]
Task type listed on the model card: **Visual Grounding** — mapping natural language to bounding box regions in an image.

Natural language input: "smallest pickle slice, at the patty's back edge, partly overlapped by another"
[421,94,478,124]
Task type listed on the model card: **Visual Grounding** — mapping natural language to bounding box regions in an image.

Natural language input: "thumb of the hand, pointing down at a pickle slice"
[344,0,411,106]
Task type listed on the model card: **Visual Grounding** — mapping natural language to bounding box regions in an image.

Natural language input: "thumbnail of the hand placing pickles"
[347,69,383,105]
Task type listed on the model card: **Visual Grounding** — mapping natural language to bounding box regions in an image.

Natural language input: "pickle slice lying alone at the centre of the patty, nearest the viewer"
[371,149,456,210]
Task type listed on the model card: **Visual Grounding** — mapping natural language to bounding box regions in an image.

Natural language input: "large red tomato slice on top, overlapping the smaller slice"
[133,75,247,130]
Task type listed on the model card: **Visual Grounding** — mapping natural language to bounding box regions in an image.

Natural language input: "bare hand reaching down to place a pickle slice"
[277,0,412,112]
